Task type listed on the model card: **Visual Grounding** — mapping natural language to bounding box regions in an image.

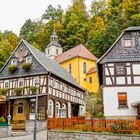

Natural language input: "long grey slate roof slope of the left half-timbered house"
[22,40,82,89]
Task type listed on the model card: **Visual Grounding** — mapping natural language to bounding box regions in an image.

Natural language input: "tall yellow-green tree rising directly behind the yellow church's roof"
[63,0,88,50]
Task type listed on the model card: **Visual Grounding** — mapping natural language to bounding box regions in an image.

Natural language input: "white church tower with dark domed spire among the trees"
[45,31,63,59]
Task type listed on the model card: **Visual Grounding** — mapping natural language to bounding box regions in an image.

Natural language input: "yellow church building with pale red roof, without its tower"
[54,44,99,92]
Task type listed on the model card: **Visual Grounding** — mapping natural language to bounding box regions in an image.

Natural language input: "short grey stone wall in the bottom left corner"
[0,126,12,138]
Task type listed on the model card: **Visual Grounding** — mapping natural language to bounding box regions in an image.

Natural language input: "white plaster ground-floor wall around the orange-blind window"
[103,87,140,116]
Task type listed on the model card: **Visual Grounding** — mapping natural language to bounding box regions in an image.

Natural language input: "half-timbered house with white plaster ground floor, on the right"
[97,26,140,119]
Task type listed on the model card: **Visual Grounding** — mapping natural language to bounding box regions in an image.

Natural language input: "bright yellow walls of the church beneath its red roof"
[60,57,99,92]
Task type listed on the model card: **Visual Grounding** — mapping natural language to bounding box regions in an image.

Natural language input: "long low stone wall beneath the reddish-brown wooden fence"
[49,131,140,140]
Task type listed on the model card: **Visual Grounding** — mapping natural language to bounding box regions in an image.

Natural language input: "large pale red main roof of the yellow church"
[54,44,98,63]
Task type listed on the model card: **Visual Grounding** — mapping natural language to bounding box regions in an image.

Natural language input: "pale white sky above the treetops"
[0,0,92,35]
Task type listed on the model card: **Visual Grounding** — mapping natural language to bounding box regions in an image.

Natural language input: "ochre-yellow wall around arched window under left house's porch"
[13,99,27,120]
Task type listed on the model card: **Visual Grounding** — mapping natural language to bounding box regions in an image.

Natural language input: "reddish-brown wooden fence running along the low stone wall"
[48,118,140,134]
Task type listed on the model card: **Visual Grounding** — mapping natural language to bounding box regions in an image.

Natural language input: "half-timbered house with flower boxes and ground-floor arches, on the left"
[0,40,84,121]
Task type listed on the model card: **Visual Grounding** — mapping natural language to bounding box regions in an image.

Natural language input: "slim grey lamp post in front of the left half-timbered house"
[34,82,40,140]
